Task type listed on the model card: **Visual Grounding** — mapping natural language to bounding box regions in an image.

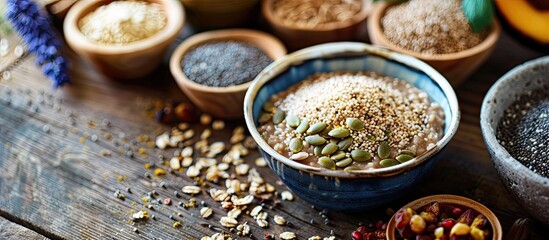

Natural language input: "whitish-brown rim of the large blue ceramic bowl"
[244,42,460,178]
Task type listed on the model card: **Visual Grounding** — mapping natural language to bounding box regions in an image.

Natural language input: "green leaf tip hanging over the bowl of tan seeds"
[462,0,494,33]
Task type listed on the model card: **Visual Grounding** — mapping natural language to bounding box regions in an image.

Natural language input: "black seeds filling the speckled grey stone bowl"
[496,89,549,178]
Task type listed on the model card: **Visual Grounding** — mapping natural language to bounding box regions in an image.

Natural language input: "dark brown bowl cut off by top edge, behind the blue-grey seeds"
[181,0,259,29]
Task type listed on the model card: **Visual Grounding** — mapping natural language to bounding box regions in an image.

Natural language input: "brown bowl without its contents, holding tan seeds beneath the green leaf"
[368,3,500,86]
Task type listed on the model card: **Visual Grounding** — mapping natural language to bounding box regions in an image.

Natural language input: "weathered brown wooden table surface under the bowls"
[0,23,549,239]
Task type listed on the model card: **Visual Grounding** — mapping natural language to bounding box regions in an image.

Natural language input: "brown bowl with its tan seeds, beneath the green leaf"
[368,0,500,86]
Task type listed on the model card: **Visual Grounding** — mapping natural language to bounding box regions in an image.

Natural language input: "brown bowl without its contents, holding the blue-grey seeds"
[170,29,286,119]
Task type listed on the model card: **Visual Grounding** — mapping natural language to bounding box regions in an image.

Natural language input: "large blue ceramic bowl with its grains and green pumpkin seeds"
[244,42,459,210]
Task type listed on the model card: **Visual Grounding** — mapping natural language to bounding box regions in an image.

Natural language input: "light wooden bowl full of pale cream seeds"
[63,0,185,79]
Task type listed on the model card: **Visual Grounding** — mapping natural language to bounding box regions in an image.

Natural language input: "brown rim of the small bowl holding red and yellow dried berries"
[387,194,503,240]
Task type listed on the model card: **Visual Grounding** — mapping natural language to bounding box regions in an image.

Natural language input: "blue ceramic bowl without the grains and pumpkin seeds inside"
[244,42,460,210]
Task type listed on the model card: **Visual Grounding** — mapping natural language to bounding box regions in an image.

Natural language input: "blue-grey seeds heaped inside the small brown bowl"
[181,41,272,87]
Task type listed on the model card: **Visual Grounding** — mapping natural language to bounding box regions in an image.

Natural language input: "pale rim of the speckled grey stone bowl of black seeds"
[480,56,549,185]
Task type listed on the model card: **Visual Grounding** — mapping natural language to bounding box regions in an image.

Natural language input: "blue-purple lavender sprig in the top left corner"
[6,0,70,88]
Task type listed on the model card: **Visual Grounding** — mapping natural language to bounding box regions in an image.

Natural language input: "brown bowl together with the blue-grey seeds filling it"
[170,29,286,119]
